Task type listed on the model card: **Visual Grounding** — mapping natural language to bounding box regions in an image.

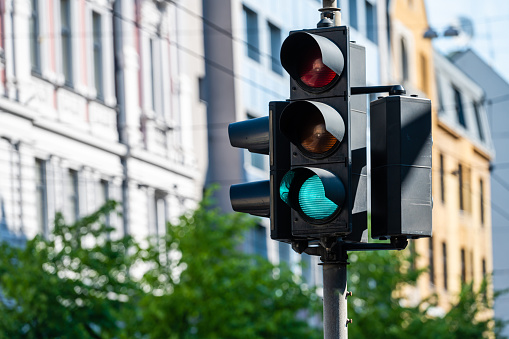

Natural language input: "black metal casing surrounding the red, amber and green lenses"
[281,26,367,242]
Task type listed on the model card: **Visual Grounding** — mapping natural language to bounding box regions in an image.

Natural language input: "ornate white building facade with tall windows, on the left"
[0,0,206,246]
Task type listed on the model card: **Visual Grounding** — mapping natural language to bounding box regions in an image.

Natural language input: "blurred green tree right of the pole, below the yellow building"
[348,251,503,339]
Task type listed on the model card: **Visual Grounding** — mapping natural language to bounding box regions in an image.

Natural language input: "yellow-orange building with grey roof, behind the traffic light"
[389,0,493,310]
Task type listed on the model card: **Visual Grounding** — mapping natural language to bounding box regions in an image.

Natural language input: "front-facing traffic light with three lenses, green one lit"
[273,26,367,241]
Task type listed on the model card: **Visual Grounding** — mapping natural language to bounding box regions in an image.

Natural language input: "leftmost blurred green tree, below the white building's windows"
[0,202,137,338]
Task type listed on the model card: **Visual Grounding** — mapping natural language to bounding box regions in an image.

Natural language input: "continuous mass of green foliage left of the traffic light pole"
[0,201,322,339]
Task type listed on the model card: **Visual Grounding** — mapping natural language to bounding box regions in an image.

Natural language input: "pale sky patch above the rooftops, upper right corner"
[425,0,509,82]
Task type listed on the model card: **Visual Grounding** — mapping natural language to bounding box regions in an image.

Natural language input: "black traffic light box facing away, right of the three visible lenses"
[370,95,432,239]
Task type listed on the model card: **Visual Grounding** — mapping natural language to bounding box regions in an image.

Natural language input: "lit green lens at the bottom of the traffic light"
[299,175,339,220]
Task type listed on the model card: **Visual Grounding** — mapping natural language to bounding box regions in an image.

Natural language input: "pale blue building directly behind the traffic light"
[203,0,388,284]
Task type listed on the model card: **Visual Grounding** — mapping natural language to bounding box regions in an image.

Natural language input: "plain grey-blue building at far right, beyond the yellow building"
[451,49,509,336]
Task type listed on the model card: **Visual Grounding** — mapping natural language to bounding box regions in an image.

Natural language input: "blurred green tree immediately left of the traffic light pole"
[136,197,323,339]
